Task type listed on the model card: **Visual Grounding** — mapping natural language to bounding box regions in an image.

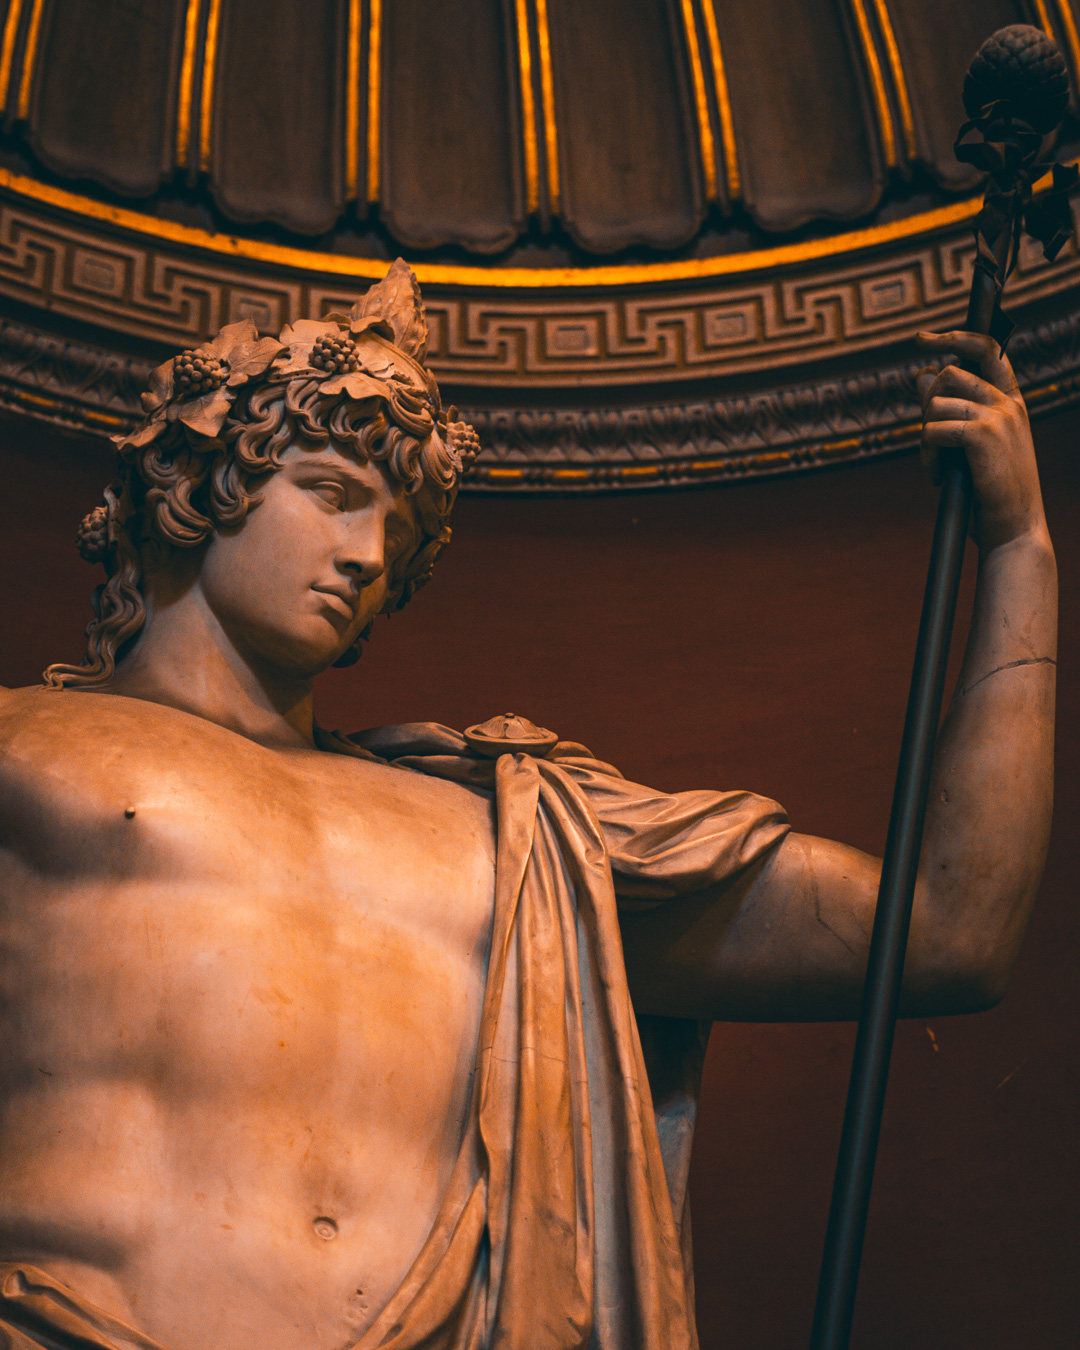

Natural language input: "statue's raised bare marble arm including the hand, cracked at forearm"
[624,333,1057,1021]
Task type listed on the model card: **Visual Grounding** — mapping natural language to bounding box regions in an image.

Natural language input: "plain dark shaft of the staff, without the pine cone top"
[810,231,1010,1350]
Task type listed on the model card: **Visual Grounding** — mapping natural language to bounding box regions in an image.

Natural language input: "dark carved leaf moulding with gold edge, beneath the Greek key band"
[0,312,1080,491]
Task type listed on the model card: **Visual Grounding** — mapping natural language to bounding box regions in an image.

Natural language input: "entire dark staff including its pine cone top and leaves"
[810,24,1077,1350]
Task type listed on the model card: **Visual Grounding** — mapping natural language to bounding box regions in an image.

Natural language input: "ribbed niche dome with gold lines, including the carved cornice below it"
[0,0,1080,491]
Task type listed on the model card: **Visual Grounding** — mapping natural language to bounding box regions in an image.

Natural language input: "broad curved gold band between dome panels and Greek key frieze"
[0,161,1031,290]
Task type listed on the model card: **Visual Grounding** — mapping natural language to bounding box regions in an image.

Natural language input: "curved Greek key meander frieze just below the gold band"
[0,190,1080,390]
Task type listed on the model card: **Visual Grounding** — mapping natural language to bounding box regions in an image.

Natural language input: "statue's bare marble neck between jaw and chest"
[107,579,315,748]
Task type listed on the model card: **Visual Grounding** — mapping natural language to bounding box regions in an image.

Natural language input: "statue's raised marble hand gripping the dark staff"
[918,332,1045,551]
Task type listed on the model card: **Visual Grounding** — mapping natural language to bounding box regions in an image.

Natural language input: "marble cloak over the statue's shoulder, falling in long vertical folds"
[317,724,788,1350]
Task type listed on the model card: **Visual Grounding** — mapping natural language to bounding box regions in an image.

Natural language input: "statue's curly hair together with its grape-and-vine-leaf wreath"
[45,261,478,687]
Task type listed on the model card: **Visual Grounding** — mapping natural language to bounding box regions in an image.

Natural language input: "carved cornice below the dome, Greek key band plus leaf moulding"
[0,159,1080,491]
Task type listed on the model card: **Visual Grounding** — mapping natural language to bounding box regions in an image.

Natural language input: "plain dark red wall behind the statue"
[0,414,1080,1350]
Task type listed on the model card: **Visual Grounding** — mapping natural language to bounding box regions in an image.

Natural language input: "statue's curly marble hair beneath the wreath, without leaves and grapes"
[43,373,477,689]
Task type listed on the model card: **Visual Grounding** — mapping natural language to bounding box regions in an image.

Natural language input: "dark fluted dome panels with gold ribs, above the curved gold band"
[0,0,1077,255]
